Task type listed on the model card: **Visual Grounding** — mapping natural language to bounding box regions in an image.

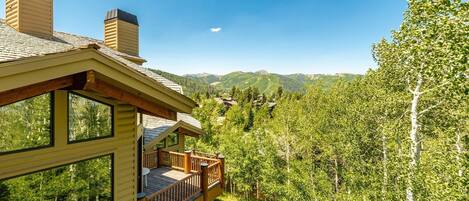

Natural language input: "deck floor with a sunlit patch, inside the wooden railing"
[144,167,189,195]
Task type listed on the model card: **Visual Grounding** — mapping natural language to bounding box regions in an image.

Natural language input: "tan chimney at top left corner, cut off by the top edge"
[5,0,53,38]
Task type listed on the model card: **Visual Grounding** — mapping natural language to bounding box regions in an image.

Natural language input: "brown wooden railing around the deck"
[143,150,225,201]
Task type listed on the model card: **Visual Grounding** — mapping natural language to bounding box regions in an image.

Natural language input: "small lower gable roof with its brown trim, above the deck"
[143,113,203,147]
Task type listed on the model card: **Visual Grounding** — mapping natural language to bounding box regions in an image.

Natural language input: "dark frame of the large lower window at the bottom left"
[0,152,115,200]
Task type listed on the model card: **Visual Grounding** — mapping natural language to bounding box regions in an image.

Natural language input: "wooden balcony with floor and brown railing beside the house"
[143,150,224,201]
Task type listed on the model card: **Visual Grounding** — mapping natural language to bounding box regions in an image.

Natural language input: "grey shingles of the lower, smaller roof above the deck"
[143,113,202,144]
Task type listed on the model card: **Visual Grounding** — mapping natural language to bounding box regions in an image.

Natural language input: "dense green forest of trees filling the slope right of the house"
[188,0,469,201]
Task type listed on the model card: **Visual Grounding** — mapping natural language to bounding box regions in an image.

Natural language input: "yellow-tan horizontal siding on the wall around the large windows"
[0,91,137,201]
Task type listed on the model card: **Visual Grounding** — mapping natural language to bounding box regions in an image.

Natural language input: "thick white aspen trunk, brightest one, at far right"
[406,74,423,201]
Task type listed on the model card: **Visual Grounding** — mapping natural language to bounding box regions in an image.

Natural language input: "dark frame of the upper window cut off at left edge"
[0,91,55,156]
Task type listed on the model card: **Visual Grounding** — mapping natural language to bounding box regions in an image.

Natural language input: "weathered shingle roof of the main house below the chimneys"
[0,20,182,94]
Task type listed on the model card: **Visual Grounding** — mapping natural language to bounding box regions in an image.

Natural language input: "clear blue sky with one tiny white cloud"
[0,0,406,75]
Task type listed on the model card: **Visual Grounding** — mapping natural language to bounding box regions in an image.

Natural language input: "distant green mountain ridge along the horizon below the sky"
[149,69,361,96]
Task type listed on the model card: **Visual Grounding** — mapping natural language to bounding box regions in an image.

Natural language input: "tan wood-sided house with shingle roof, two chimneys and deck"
[0,0,224,201]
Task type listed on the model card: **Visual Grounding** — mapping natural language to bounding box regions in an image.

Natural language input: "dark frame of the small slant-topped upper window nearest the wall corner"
[67,91,115,144]
